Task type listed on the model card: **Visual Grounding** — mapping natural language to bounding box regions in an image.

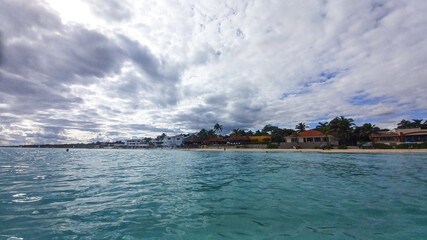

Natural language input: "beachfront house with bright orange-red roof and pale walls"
[280,129,338,148]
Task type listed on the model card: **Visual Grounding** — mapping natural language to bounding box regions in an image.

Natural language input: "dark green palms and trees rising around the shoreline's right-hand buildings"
[197,116,427,145]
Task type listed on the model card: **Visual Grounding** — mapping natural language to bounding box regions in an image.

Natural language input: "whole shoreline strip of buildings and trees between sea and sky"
[4,116,427,149]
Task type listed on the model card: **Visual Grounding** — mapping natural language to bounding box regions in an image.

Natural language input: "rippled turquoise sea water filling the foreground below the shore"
[0,148,427,239]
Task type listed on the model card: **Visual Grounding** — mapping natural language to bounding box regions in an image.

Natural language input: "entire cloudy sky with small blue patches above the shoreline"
[0,0,427,145]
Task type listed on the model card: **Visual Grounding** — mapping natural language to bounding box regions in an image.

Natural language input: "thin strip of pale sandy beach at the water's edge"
[184,148,427,153]
